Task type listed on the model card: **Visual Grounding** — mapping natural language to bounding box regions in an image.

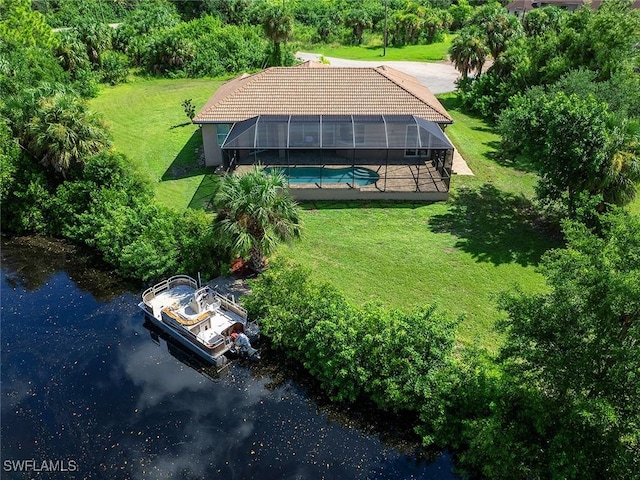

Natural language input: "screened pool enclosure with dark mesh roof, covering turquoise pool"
[222,115,454,197]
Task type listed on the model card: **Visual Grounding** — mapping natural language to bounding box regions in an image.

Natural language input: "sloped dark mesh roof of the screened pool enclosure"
[222,115,453,150]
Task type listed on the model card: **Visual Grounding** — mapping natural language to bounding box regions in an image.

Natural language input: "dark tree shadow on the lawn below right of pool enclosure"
[429,184,561,266]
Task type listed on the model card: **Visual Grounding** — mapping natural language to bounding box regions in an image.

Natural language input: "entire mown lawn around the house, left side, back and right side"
[92,79,557,349]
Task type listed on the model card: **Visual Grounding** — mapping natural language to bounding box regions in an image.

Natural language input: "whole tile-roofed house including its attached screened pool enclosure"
[193,62,454,200]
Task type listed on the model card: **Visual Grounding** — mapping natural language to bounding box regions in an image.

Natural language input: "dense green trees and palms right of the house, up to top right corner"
[450,0,640,216]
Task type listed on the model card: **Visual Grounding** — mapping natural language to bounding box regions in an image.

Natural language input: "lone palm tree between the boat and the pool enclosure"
[214,166,301,271]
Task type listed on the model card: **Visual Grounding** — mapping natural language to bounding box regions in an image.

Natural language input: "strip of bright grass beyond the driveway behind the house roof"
[307,37,451,62]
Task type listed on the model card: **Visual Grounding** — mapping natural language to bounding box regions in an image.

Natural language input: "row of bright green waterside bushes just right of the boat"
[245,264,457,425]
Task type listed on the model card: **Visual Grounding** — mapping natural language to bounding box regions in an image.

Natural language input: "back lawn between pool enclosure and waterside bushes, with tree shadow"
[278,198,548,349]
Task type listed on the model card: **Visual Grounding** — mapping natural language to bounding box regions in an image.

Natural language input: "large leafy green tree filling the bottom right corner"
[496,209,640,479]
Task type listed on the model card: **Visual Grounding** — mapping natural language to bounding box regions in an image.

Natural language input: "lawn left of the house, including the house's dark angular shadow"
[91,79,229,209]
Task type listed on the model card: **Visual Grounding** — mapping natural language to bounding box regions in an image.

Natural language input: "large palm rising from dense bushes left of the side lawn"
[26,93,109,178]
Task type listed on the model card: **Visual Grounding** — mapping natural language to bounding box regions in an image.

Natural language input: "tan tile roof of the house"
[193,62,452,123]
